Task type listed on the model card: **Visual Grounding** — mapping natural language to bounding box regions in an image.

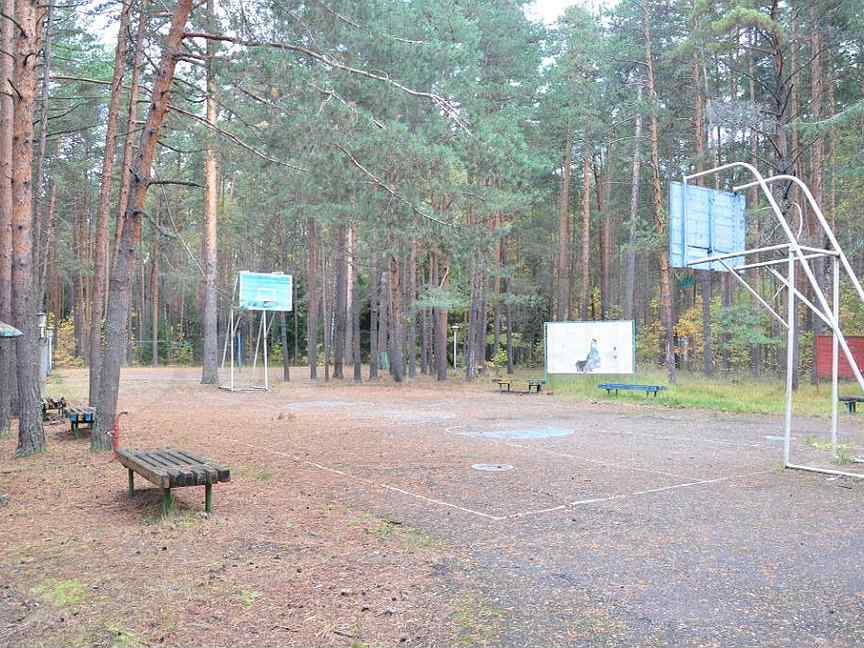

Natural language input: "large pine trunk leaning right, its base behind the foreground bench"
[90,0,192,450]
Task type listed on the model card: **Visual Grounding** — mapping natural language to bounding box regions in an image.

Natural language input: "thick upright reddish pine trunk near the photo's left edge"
[12,0,45,457]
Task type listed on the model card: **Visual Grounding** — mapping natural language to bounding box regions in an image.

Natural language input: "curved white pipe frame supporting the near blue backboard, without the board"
[681,162,864,479]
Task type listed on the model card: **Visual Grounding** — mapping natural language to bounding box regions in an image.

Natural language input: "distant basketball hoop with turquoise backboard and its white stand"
[219,272,293,391]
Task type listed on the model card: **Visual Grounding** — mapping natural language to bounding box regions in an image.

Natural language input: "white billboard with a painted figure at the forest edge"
[546,320,636,374]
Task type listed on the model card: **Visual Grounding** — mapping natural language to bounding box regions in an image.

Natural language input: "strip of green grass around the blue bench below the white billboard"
[506,368,843,416]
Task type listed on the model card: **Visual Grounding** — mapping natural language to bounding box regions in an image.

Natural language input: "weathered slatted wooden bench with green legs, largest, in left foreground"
[117,448,231,516]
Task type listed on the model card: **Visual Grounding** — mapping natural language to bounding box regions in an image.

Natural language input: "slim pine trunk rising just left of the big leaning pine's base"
[89,0,132,405]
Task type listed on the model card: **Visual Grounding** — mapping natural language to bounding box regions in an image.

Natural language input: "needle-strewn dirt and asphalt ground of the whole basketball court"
[0,369,864,648]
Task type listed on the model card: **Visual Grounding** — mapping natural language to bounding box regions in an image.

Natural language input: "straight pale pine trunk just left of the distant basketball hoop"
[201,0,218,385]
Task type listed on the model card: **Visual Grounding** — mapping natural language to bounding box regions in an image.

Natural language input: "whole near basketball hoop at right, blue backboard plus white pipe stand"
[669,162,864,478]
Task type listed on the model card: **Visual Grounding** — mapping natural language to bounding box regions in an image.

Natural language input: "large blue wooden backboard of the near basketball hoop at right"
[669,182,747,271]
